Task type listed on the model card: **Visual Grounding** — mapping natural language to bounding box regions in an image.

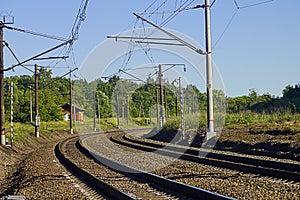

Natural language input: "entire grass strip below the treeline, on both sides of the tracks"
[6,112,300,145]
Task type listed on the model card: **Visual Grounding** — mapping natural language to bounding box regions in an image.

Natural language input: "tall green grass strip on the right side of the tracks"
[165,111,300,134]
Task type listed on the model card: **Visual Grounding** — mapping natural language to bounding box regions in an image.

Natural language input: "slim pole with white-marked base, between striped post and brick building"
[34,64,40,137]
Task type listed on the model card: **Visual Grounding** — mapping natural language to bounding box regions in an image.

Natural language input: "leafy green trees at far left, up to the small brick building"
[4,68,70,123]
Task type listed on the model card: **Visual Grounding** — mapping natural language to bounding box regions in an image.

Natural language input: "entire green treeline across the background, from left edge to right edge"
[5,68,300,122]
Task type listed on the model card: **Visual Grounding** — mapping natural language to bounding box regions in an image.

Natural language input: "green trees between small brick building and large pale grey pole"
[74,76,206,118]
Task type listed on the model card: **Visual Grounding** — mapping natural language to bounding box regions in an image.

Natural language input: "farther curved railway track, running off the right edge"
[110,133,300,182]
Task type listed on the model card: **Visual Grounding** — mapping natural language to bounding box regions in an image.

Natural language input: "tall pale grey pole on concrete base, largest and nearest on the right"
[205,0,216,140]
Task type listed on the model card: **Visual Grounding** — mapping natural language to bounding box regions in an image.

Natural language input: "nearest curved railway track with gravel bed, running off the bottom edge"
[55,134,232,199]
